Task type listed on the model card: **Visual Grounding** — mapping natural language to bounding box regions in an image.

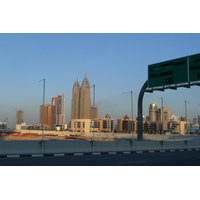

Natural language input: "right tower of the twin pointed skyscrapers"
[79,77,91,119]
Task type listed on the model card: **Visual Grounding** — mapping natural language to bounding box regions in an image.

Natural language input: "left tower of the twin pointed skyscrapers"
[71,79,80,119]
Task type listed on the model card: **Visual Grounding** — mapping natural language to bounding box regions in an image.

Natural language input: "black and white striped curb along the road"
[0,148,200,158]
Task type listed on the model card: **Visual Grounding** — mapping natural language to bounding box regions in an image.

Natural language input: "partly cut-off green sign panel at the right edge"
[189,54,200,82]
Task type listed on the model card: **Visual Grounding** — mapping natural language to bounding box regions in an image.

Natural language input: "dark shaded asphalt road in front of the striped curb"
[0,151,200,166]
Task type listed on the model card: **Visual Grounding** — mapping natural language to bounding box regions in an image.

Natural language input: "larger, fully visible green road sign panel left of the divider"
[148,57,188,88]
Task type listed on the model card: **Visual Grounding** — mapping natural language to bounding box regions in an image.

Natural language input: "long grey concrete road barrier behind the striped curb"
[0,140,200,155]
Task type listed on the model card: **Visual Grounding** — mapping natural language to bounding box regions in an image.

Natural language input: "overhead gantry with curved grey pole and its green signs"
[137,53,200,140]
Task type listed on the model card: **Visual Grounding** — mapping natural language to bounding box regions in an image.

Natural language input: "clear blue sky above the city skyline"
[0,33,200,127]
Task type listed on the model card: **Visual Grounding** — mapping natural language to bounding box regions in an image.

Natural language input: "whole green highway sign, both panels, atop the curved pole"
[148,53,200,88]
